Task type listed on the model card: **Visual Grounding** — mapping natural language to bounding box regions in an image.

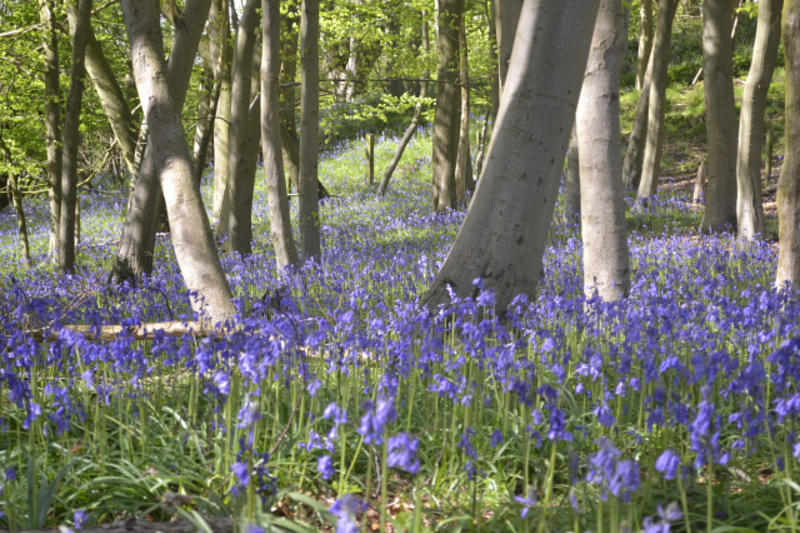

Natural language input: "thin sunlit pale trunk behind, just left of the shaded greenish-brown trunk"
[208,0,232,226]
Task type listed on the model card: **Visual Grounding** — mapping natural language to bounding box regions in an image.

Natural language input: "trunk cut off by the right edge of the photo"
[775,0,800,290]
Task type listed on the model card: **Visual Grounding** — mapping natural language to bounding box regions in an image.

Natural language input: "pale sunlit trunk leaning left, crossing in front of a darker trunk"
[122,0,236,323]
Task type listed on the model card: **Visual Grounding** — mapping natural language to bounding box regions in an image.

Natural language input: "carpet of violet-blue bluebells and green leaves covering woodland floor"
[0,131,800,532]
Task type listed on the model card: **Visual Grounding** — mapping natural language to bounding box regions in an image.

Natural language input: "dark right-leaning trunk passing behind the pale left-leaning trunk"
[111,0,216,280]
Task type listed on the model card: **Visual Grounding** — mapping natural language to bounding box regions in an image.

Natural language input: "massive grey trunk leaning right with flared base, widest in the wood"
[423,0,598,312]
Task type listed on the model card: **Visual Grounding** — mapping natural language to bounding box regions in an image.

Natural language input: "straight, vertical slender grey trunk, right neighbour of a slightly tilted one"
[299,0,321,259]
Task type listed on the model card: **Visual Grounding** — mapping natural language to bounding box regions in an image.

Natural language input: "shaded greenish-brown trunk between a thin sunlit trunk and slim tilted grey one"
[222,0,261,255]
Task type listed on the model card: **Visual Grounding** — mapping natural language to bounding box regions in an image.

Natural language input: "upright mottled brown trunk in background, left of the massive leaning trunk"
[433,0,464,211]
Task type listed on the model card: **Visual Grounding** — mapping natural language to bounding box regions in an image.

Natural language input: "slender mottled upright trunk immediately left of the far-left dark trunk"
[39,0,62,261]
